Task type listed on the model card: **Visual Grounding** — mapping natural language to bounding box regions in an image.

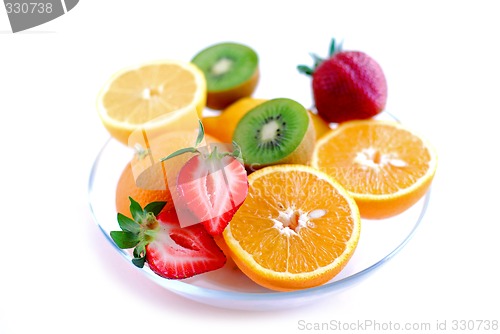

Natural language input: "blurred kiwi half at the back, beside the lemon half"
[192,42,259,110]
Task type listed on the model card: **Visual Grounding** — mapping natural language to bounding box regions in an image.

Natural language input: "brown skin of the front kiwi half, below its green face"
[235,100,316,173]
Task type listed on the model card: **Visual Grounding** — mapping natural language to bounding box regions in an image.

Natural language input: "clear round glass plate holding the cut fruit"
[88,119,430,310]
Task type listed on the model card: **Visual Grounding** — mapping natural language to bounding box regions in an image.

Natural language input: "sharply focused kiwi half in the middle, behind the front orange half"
[233,98,315,171]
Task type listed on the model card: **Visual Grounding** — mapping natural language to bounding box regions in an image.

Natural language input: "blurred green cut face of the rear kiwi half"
[192,42,259,92]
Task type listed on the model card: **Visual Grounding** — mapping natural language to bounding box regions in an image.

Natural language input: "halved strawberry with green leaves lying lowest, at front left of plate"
[110,198,226,279]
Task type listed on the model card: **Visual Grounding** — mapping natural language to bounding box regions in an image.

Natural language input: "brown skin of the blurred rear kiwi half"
[207,67,260,110]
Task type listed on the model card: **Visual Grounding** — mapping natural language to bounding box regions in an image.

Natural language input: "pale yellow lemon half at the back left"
[97,60,206,146]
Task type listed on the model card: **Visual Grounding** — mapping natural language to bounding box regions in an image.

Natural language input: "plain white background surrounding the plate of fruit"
[0,0,500,334]
